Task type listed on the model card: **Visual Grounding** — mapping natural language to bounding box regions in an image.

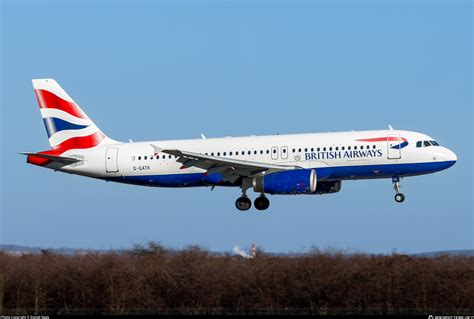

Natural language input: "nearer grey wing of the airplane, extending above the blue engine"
[152,145,301,183]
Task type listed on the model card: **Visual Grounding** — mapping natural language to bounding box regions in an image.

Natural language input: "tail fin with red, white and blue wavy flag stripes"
[33,79,117,151]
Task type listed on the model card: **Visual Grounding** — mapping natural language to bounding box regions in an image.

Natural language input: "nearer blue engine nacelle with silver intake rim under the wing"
[253,169,318,195]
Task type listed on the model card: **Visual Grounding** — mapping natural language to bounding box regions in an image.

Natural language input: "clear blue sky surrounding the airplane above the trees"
[0,1,474,253]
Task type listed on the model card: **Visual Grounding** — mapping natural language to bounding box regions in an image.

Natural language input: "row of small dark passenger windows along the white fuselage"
[132,141,380,161]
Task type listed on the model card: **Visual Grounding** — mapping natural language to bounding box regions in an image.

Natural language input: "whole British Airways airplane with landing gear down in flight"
[21,79,457,211]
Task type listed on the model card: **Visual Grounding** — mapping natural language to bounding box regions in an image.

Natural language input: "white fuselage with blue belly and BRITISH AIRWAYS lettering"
[50,130,457,187]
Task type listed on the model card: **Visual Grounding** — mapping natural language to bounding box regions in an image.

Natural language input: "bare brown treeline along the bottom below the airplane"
[0,243,474,315]
